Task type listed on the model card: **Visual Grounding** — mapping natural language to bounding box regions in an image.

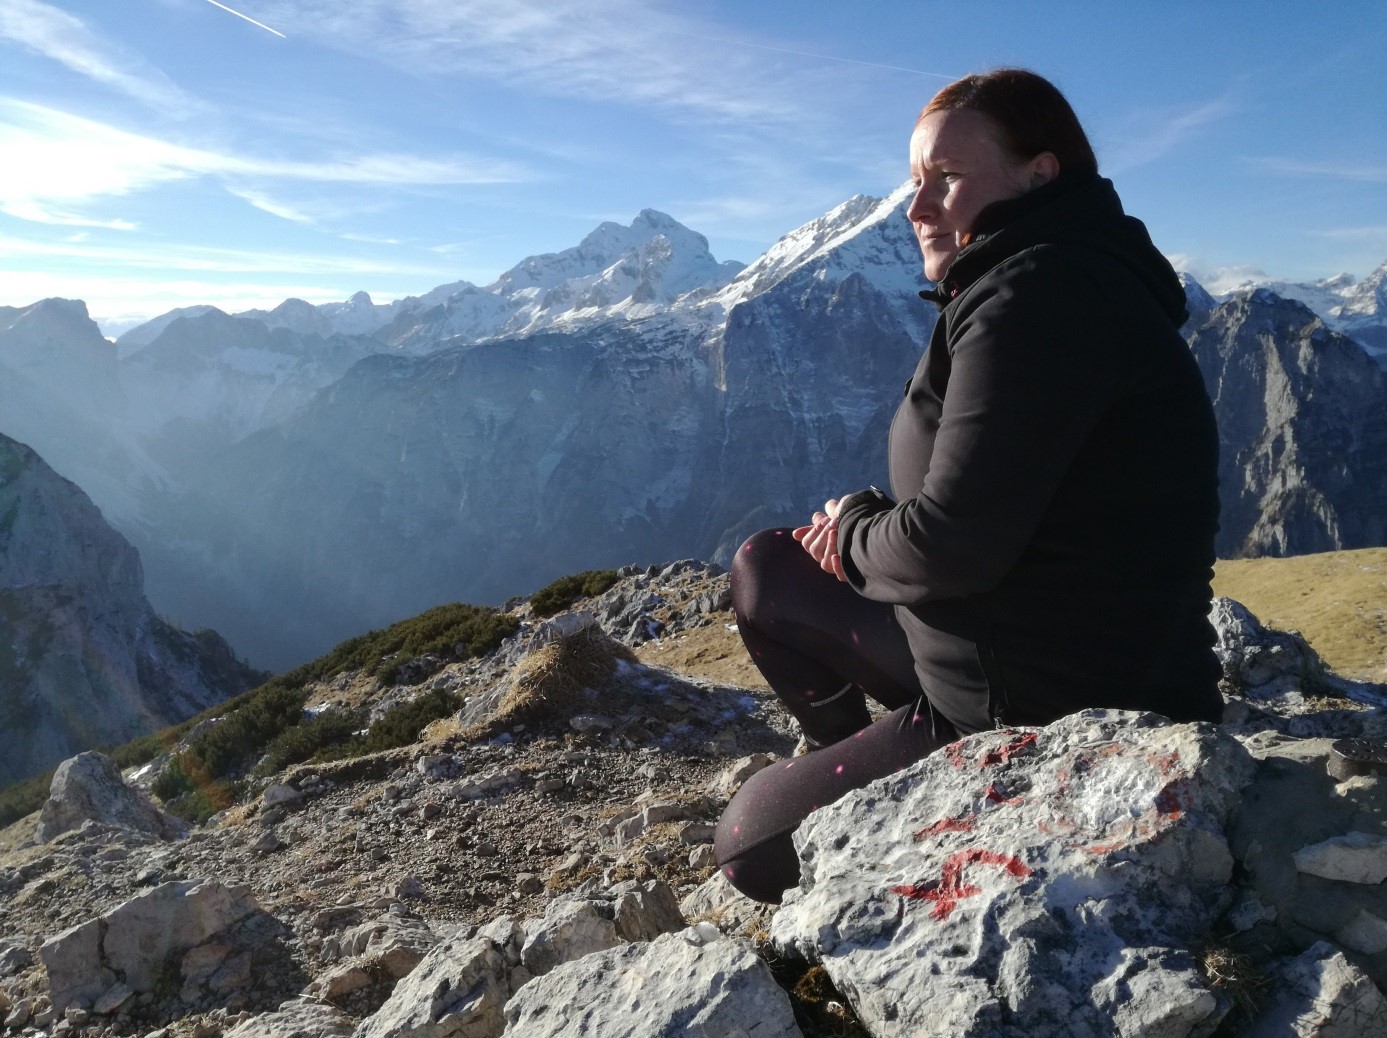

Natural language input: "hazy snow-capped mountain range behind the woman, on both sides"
[0,192,1387,666]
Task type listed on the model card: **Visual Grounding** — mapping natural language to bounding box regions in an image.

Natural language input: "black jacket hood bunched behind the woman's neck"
[920,173,1189,327]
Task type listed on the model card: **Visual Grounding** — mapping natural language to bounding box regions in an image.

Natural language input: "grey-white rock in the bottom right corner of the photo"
[1246,941,1387,1038]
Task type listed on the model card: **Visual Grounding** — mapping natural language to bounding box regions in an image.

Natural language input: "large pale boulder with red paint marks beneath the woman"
[771,711,1252,1038]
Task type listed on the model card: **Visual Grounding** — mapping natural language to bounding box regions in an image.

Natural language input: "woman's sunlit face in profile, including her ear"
[906,108,1054,282]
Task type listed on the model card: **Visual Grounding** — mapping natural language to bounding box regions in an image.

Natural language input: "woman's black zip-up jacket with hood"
[838,175,1222,733]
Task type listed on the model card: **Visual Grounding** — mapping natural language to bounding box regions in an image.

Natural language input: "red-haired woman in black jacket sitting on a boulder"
[716,69,1222,902]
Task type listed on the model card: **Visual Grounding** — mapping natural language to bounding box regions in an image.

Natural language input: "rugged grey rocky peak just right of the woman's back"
[1190,289,1387,558]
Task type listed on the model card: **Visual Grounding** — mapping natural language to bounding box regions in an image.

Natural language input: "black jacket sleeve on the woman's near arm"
[838,250,1122,605]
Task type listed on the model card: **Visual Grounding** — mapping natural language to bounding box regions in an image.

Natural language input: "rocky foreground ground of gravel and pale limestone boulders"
[8,574,1387,1038]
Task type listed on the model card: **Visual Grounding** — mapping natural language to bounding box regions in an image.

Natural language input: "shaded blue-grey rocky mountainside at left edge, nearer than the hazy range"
[0,436,259,781]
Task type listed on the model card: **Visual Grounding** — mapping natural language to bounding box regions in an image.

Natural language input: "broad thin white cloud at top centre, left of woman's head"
[257,0,810,124]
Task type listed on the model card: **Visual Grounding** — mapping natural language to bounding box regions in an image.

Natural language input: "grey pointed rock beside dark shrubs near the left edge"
[35,751,183,844]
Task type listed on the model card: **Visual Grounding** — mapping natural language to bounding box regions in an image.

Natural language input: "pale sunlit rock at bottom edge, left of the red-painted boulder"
[505,931,800,1038]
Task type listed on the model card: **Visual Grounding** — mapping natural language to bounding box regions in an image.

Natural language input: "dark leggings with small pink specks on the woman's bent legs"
[714,529,958,903]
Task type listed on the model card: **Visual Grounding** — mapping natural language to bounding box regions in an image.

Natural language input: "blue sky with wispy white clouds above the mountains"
[0,0,1387,330]
